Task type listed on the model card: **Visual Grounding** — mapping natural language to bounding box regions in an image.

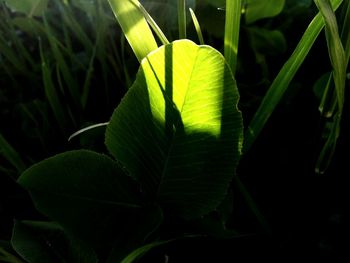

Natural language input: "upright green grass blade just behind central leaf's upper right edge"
[224,0,242,74]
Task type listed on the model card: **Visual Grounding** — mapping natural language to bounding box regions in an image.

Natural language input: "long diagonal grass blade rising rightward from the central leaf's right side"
[243,0,342,152]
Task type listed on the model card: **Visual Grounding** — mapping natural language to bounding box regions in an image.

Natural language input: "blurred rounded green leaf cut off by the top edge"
[245,0,285,24]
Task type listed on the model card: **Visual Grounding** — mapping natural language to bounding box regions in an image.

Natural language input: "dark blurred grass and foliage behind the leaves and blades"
[0,0,349,262]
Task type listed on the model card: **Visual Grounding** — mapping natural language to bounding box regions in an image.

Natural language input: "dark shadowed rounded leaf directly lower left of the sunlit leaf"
[18,150,143,248]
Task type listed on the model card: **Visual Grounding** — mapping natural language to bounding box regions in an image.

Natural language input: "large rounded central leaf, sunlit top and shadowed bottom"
[106,40,243,218]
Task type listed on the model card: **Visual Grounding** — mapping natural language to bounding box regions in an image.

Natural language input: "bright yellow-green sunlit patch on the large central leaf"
[142,41,225,137]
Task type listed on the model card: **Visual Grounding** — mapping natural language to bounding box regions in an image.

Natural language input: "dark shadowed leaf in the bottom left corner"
[11,221,98,263]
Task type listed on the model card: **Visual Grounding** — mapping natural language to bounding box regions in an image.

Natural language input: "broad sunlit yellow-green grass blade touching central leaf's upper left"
[108,0,158,61]
